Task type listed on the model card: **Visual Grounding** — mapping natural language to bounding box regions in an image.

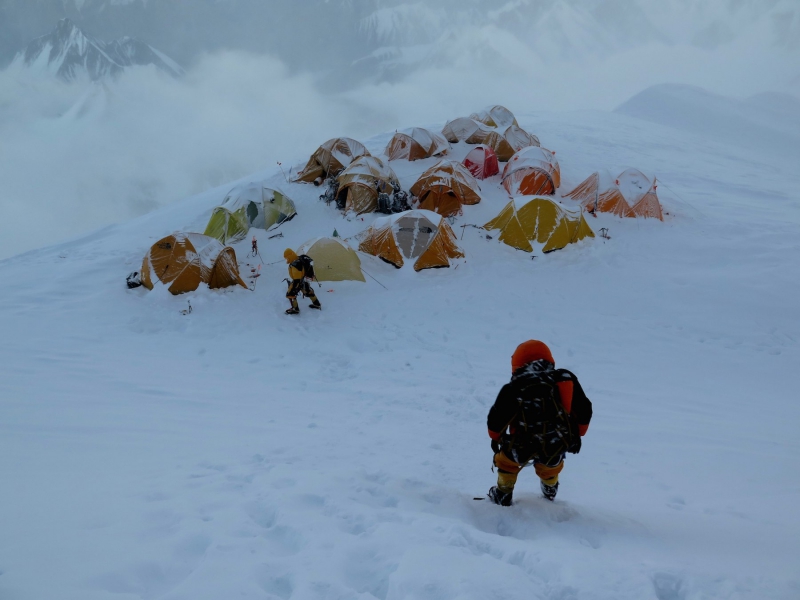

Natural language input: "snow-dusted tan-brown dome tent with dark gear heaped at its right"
[337,156,399,215]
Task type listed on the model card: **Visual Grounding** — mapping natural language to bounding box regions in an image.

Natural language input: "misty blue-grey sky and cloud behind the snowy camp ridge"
[0,0,800,258]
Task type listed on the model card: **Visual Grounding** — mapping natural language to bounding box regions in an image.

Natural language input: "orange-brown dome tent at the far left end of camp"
[142,233,247,295]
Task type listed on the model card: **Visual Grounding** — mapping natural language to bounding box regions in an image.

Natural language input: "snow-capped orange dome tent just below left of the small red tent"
[411,160,481,217]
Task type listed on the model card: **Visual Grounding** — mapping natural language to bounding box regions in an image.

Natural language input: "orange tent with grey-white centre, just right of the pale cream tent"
[358,210,464,271]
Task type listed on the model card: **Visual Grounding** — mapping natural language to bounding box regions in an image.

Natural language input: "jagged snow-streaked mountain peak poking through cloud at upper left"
[12,19,184,81]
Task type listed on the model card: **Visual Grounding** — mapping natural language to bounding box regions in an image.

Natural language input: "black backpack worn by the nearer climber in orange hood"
[509,369,580,464]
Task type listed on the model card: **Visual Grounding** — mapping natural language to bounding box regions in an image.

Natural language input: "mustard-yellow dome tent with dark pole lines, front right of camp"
[483,197,594,252]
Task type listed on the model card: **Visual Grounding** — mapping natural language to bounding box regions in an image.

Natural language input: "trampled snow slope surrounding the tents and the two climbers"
[0,92,800,600]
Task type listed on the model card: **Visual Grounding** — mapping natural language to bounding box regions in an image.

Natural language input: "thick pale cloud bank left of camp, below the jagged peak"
[0,52,363,257]
